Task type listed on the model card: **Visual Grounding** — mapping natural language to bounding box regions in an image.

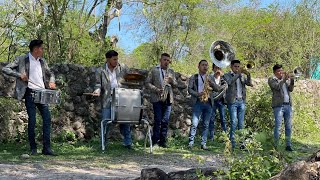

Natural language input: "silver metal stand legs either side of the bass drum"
[101,119,152,153]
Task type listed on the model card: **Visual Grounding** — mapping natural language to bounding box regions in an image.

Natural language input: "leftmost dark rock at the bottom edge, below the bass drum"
[140,168,170,180]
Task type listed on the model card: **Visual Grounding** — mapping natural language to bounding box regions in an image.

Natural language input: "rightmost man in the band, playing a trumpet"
[268,64,294,151]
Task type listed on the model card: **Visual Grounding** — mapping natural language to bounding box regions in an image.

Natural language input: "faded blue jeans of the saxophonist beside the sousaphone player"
[189,101,212,145]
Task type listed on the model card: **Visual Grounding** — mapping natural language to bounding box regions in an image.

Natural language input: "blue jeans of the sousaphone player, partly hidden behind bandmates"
[209,99,227,139]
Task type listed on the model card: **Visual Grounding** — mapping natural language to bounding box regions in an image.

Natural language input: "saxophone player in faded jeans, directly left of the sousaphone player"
[188,60,223,150]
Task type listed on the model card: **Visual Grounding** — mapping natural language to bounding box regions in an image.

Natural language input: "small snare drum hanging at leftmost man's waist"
[32,89,60,104]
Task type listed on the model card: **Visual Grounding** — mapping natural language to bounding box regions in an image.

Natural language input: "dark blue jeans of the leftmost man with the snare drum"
[25,93,51,150]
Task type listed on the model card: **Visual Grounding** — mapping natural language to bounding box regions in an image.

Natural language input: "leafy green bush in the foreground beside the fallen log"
[222,129,285,179]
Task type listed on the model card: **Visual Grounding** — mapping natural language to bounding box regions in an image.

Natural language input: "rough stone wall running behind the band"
[0,63,320,139]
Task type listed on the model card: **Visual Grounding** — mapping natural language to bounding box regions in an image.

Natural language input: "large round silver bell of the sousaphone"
[209,40,235,68]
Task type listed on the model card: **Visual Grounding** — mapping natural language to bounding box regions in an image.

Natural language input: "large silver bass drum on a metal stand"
[111,88,143,124]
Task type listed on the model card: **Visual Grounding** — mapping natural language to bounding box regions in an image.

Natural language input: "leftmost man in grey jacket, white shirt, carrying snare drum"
[2,40,56,156]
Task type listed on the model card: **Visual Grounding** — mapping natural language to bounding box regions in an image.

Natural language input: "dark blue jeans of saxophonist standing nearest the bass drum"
[152,101,171,144]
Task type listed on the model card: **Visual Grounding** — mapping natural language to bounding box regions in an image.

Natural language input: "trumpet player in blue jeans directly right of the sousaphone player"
[223,60,253,149]
